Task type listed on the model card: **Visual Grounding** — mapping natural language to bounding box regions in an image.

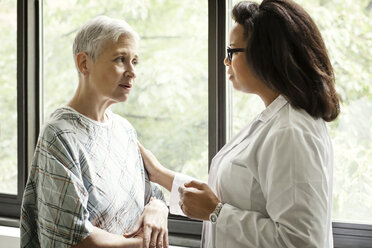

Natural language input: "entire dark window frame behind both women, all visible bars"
[0,0,372,248]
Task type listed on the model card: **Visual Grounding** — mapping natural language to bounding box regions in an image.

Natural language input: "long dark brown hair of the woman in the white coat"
[232,0,341,121]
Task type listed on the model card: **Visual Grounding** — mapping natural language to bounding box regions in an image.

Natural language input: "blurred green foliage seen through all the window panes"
[0,0,372,224]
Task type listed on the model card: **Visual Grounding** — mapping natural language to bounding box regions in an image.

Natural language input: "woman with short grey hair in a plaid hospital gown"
[21,16,168,247]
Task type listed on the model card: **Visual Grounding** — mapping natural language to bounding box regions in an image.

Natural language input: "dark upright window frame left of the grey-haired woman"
[0,0,42,221]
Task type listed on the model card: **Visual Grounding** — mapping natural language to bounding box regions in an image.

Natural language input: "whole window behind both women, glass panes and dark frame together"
[0,0,372,247]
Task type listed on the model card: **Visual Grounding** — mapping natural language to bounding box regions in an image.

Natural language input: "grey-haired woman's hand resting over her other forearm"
[125,198,168,248]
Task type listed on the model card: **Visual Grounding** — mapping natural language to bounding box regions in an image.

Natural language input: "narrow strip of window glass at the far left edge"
[0,0,17,194]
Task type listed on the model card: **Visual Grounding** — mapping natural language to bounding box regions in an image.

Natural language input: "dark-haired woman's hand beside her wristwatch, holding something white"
[178,180,220,220]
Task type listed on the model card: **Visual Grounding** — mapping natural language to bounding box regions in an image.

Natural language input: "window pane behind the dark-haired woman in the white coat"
[233,0,372,224]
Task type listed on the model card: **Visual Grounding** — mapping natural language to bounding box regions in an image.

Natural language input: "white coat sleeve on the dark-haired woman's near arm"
[216,128,331,247]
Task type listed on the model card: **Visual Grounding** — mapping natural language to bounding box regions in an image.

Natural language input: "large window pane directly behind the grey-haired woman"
[44,0,208,202]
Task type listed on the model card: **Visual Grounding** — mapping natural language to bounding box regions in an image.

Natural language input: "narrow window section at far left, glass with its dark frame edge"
[0,0,27,217]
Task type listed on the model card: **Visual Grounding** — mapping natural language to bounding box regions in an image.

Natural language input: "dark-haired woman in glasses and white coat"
[141,0,339,248]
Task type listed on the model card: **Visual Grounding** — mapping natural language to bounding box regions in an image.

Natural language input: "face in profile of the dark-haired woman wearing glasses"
[224,23,263,93]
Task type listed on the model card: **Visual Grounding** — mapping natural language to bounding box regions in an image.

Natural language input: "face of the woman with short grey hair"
[87,36,138,103]
